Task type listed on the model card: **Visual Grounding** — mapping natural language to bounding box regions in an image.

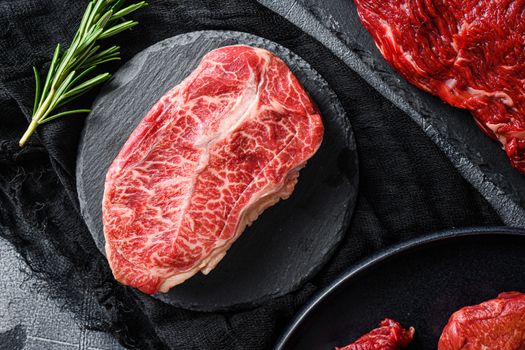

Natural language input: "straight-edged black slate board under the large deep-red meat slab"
[258,0,525,227]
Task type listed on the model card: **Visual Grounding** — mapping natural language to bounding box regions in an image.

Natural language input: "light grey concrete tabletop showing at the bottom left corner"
[0,239,124,350]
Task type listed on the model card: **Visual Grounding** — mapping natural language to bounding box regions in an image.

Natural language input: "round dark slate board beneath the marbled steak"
[77,31,358,311]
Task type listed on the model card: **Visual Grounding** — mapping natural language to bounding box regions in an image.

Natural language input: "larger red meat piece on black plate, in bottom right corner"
[438,292,525,350]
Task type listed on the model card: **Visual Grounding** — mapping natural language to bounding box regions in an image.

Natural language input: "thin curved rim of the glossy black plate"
[274,226,525,350]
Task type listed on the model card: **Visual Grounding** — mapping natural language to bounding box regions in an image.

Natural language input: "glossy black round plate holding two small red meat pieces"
[276,228,525,350]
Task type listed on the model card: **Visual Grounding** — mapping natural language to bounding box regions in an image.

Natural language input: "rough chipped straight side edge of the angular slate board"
[258,0,525,227]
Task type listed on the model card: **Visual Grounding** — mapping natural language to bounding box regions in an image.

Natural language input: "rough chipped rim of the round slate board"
[76,30,359,312]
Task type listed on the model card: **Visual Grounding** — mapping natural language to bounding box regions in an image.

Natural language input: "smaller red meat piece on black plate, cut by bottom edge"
[336,318,414,350]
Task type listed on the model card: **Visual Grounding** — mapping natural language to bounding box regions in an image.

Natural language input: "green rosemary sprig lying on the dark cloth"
[20,0,148,147]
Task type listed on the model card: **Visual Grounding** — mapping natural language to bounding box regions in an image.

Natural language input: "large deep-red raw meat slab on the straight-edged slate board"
[354,0,525,173]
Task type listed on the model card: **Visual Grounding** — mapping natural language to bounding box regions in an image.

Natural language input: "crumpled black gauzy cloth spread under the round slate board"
[0,0,500,349]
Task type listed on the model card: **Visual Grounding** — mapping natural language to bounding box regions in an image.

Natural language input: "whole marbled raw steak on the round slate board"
[102,45,323,294]
